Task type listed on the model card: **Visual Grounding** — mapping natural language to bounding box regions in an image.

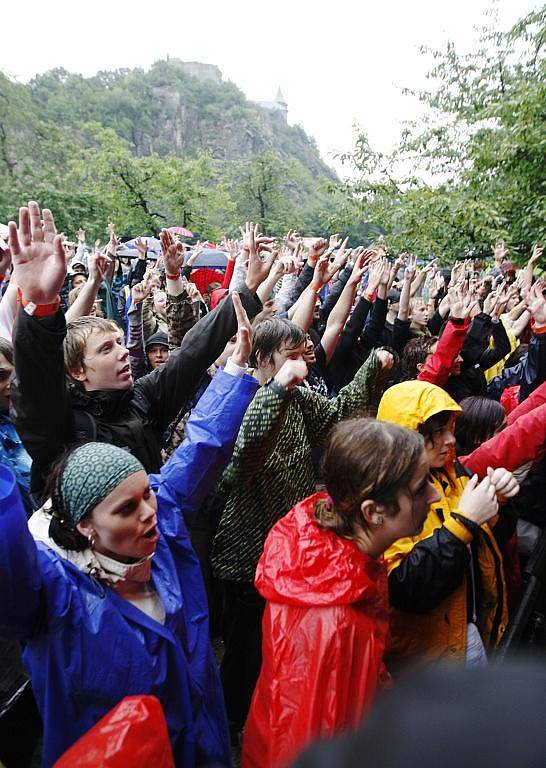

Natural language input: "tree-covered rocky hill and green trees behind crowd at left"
[0,61,335,239]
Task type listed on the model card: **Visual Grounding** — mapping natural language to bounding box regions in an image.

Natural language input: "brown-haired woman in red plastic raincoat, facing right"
[242,419,439,768]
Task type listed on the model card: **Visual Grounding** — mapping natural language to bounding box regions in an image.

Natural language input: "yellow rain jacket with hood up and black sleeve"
[377,381,508,663]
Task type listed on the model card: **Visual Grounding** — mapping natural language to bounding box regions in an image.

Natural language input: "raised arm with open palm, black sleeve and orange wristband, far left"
[9,202,75,491]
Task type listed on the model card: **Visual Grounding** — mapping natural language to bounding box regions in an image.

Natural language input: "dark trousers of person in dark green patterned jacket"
[220,581,265,734]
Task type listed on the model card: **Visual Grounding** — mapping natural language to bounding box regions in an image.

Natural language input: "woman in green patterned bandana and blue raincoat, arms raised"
[0,294,258,767]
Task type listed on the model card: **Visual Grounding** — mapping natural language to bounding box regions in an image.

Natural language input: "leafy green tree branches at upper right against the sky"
[336,6,546,262]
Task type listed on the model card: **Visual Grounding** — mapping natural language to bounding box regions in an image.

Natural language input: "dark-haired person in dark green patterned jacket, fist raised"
[208,318,393,740]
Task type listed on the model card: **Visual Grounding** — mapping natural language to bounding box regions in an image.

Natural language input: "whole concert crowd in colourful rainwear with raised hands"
[0,202,546,768]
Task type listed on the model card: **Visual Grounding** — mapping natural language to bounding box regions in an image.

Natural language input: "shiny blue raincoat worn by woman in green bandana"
[0,372,258,768]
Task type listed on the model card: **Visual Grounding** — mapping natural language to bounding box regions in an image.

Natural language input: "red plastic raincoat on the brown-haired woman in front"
[242,494,388,768]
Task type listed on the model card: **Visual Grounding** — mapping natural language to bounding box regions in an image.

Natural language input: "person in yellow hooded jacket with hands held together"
[378,381,519,664]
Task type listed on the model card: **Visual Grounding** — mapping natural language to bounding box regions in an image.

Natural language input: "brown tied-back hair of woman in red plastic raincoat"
[315,418,424,540]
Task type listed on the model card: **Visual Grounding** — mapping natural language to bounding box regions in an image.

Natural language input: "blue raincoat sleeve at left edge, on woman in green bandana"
[0,466,42,640]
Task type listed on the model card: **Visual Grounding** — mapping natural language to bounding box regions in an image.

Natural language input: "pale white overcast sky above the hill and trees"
[0,0,541,176]
